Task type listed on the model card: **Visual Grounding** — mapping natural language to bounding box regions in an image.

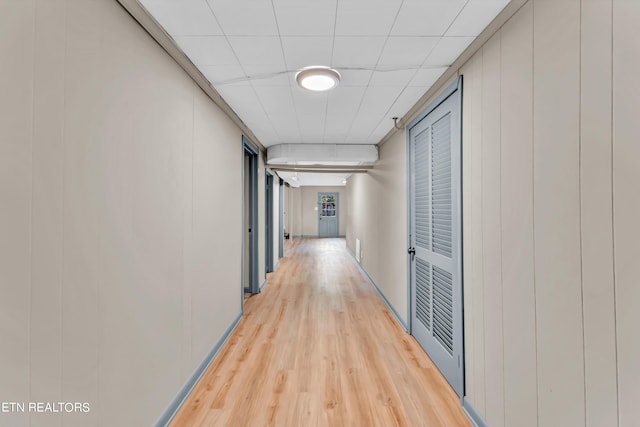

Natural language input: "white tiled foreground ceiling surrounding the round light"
[140,0,509,147]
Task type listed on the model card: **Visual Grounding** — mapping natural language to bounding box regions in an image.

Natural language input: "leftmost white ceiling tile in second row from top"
[176,36,239,66]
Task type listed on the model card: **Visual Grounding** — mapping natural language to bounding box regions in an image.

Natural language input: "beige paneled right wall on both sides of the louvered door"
[347,0,640,427]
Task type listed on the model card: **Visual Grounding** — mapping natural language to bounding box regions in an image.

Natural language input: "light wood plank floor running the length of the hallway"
[172,239,471,427]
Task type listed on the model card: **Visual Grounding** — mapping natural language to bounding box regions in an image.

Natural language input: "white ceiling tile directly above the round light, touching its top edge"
[282,36,333,70]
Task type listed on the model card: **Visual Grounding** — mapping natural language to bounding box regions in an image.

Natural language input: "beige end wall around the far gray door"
[290,187,349,236]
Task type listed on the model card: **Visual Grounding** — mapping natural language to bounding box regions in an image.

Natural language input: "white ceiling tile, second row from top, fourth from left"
[331,37,386,68]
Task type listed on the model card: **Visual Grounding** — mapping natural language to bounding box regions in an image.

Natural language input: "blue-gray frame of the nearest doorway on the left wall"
[241,135,260,294]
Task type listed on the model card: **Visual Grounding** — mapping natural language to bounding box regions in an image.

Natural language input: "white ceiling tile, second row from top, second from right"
[378,37,439,69]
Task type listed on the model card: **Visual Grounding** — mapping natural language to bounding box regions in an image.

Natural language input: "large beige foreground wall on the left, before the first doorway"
[0,0,255,426]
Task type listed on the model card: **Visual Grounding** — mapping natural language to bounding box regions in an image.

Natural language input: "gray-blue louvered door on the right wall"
[409,83,464,396]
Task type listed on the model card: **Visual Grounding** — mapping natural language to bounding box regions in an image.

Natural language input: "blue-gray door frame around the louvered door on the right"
[405,75,465,400]
